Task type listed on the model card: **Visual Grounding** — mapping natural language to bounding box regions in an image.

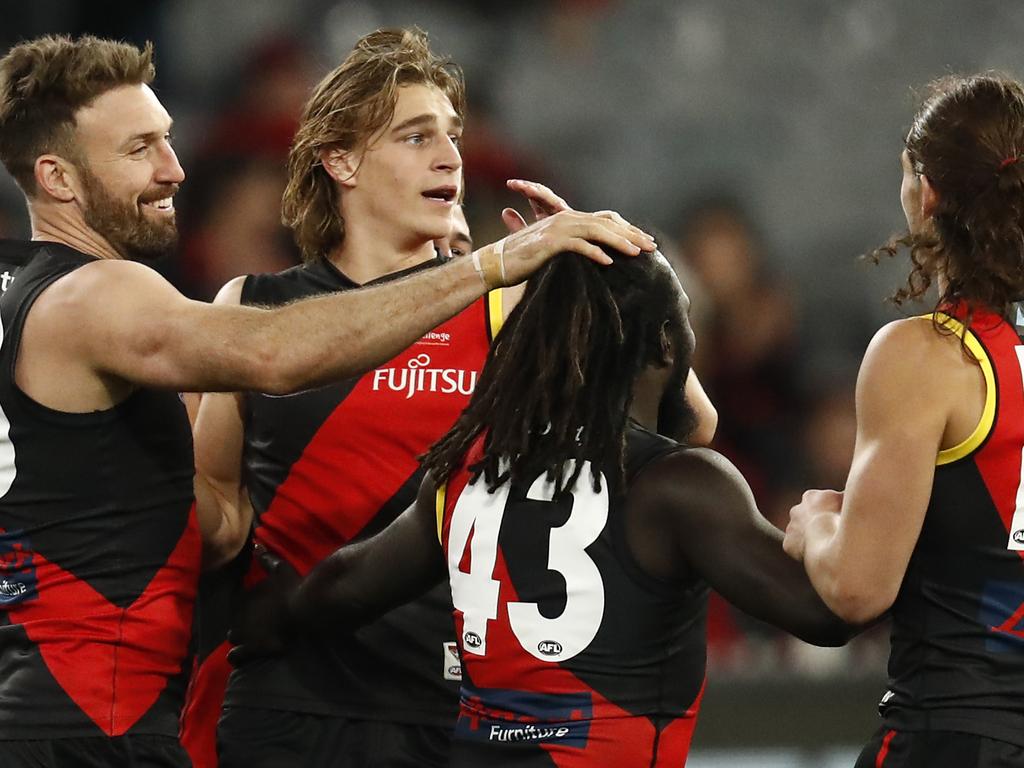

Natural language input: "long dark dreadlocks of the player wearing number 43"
[423,253,681,494]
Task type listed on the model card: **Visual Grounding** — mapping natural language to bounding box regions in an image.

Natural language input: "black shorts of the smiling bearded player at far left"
[0,735,191,768]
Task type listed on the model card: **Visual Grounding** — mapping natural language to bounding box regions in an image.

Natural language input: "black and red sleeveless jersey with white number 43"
[437,423,708,768]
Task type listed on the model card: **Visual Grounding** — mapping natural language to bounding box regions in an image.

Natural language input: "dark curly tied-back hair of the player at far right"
[869,74,1024,326]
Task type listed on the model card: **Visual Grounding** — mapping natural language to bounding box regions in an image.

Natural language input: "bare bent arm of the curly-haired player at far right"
[786,319,966,622]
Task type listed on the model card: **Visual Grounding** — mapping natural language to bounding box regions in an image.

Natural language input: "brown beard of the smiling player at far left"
[79,167,178,261]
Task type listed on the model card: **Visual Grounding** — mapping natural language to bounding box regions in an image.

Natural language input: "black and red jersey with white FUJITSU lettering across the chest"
[225,260,501,725]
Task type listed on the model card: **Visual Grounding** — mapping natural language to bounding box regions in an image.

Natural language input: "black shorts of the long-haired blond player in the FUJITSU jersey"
[218,707,454,768]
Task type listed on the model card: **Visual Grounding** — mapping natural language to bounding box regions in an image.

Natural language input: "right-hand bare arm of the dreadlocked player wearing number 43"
[627,449,856,645]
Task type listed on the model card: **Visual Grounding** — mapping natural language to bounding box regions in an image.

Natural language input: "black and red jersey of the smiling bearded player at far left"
[0,242,200,739]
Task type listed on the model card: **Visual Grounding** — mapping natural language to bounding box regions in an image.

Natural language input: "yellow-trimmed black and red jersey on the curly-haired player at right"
[881,307,1024,745]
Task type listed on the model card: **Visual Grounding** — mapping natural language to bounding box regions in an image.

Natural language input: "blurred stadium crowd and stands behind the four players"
[8,0,1024,768]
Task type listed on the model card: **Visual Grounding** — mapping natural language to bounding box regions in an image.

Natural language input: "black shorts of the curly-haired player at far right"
[855,727,1024,768]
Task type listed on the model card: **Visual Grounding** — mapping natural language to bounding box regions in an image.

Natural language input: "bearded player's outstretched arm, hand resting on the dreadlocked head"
[32,212,652,393]
